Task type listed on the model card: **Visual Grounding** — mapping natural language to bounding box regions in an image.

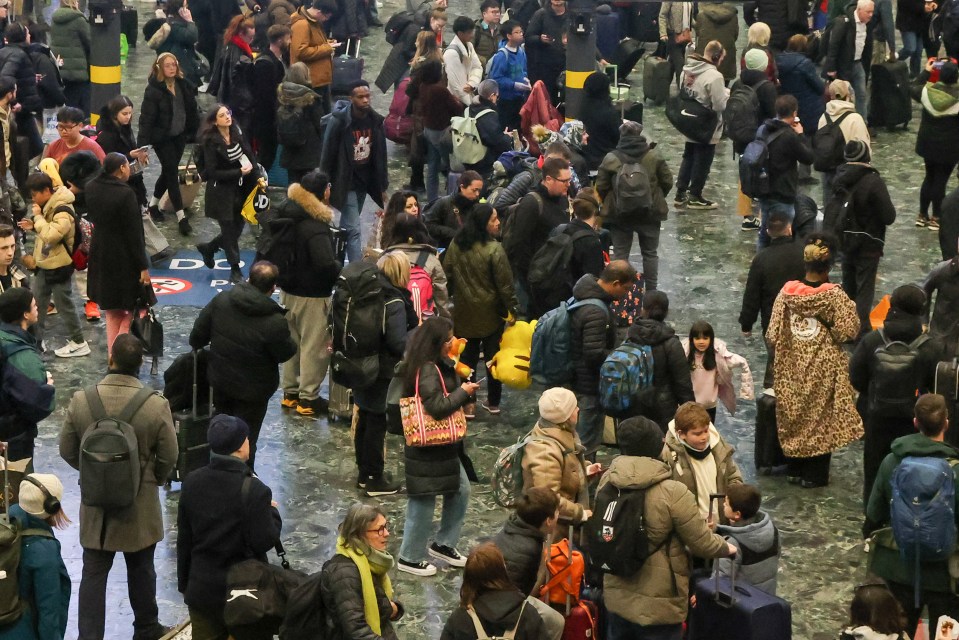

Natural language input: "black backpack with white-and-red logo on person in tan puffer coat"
[586,482,669,578]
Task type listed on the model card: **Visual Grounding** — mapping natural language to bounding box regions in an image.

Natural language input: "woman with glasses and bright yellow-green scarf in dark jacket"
[320,502,404,640]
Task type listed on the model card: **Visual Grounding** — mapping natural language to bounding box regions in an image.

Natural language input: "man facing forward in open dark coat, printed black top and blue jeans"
[320,80,390,262]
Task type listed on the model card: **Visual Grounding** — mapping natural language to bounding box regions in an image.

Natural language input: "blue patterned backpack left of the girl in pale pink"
[599,342,653,418]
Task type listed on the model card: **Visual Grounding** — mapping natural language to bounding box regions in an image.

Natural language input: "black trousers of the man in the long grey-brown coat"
[77,545,159,640]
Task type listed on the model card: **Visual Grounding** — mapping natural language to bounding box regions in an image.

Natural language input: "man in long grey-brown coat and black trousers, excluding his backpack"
[60,334,178,640]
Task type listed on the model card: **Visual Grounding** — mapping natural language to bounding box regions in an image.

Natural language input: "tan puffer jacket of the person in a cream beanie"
[523,421,589,524]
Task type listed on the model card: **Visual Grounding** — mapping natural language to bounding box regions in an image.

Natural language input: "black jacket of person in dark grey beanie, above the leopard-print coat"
[832,162,896,257]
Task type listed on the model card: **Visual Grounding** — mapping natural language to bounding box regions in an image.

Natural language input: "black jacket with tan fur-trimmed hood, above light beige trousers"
[277,183,343,298]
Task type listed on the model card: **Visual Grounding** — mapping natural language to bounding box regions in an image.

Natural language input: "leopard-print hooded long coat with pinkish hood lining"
[766,280,863,458]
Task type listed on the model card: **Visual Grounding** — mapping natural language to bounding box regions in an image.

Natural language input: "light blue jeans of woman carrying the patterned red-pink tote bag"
[400,464,470,563]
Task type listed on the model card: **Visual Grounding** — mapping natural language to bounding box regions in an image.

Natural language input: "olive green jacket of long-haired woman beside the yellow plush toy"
[443,240,518,338]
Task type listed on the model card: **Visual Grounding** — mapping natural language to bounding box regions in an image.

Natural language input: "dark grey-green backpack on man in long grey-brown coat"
[80,385,156,511]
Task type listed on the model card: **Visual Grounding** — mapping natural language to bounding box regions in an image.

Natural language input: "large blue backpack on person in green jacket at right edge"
[889,456,959,607]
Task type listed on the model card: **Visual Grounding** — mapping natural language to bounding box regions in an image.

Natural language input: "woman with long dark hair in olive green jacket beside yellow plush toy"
[443,204,517,418]
